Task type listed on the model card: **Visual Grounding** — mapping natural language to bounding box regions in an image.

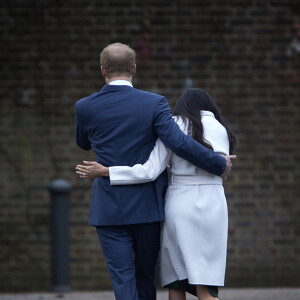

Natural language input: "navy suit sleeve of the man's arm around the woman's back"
[153,97,226,176]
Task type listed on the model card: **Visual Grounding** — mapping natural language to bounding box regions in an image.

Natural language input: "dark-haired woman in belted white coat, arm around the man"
[77,89,236,300]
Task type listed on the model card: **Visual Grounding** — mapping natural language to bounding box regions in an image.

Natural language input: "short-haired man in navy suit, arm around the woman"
[75,43,231,300]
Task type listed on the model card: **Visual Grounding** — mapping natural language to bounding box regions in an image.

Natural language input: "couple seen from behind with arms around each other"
[75,43,236,300]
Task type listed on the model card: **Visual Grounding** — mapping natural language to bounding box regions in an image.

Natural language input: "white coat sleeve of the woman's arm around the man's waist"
[109,139,172,185]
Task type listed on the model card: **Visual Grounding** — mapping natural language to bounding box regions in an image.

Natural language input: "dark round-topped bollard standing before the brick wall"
[49,179,71,292]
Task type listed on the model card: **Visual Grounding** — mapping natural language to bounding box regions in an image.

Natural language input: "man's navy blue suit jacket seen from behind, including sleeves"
[75,85,226,226]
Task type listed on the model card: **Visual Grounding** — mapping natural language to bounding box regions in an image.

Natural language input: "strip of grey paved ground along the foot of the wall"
[0,288,300,300]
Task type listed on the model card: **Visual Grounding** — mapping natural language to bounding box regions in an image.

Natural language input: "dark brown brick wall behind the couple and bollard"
[0,0,300,291]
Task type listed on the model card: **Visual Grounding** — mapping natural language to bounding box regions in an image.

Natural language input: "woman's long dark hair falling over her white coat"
[173,88,237,154]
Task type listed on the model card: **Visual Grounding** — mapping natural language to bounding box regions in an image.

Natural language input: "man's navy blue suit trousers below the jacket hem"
[96,222,160,300]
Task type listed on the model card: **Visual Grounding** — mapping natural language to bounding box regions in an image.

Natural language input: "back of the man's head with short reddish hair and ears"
[100,43,135,78]
